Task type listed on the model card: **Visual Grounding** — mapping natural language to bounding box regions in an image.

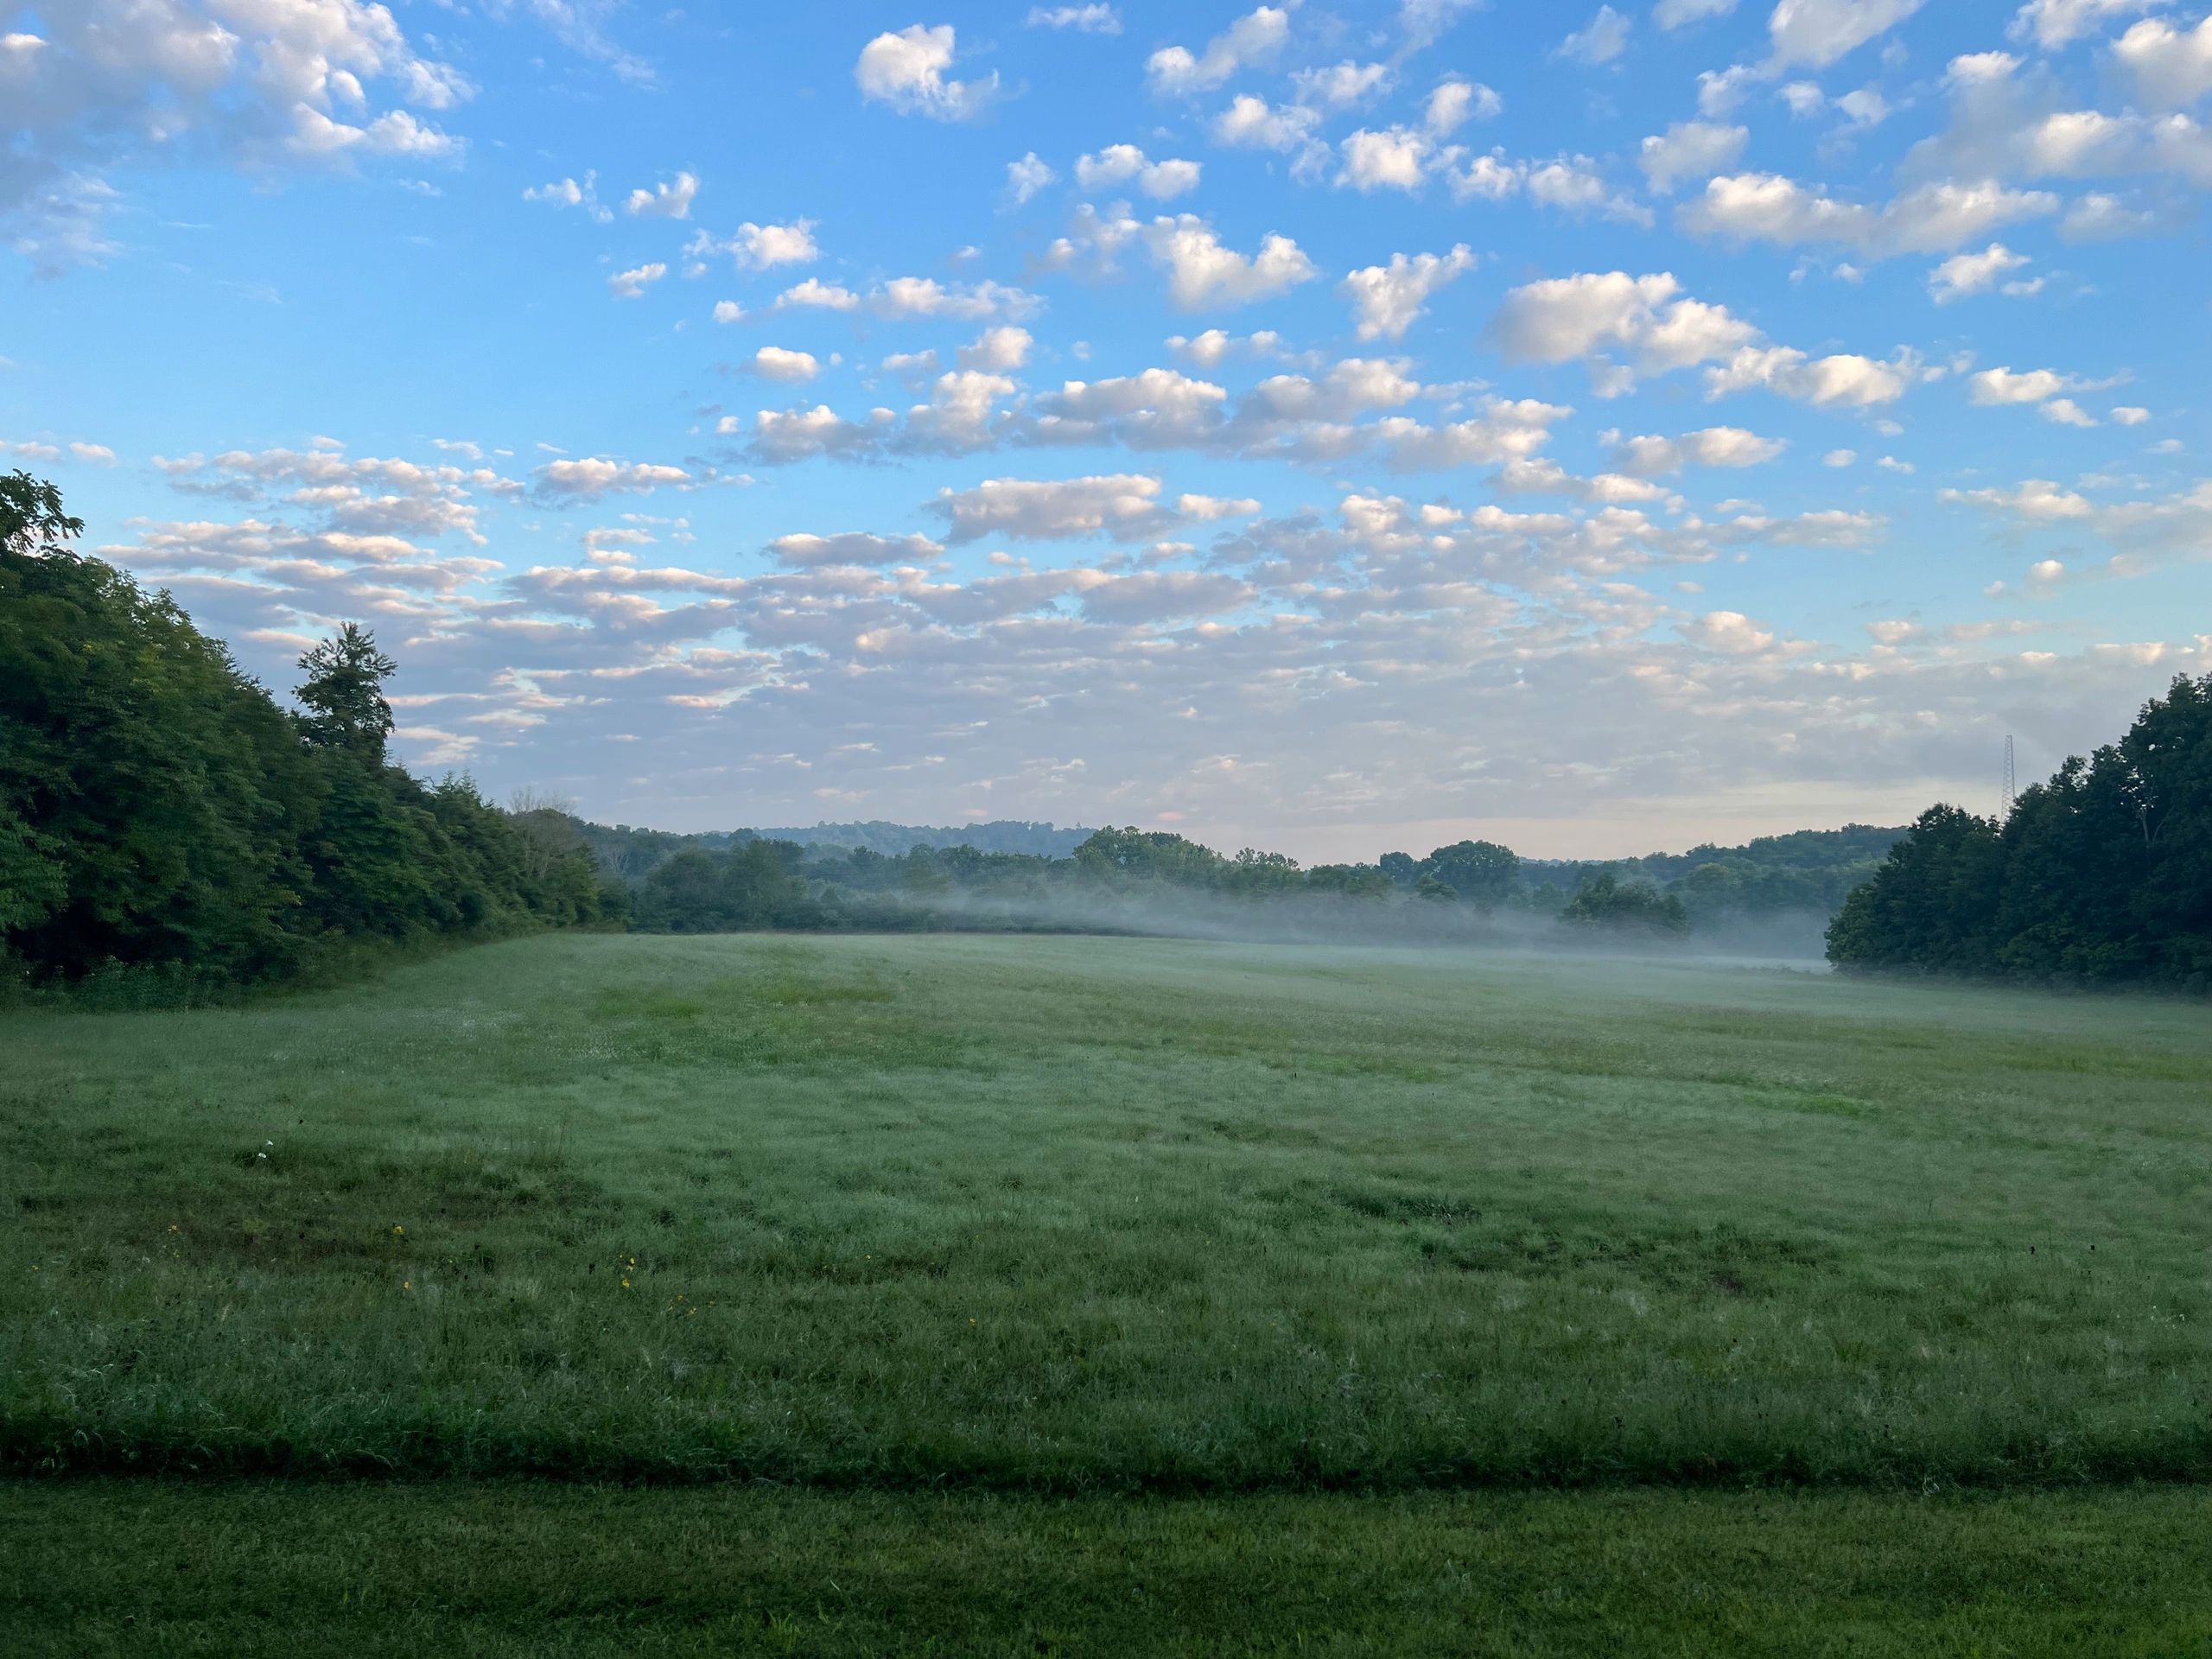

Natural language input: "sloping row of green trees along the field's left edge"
[0,471,628,1000]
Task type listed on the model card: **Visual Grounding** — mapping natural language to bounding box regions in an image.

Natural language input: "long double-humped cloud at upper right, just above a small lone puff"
[1681,173,2059,259]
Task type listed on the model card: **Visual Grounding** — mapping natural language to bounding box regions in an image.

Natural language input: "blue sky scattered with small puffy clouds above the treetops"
[0,0,2212,858]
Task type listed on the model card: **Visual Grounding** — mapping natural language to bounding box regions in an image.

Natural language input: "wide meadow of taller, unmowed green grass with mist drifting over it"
[0,936,2212,1493]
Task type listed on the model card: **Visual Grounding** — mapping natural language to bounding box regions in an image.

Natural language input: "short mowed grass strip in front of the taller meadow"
[0,1480,2212,1659]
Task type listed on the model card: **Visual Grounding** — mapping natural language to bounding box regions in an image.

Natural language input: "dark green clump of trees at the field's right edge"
[1827,675,2212,991]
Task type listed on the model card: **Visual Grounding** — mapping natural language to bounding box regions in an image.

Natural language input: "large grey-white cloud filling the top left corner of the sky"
[0,0,462,272]
